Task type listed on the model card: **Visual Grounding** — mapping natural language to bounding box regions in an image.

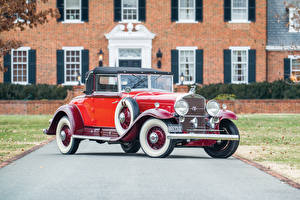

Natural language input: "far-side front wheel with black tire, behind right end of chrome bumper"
[204,120,240,158]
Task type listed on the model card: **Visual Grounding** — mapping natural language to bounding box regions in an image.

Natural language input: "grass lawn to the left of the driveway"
[0,115,51,162]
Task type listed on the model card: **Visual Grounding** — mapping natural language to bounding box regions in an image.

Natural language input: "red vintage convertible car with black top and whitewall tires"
[44,67,240,158]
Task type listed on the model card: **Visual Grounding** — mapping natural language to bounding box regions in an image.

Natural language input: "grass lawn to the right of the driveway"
[235,114,300,169]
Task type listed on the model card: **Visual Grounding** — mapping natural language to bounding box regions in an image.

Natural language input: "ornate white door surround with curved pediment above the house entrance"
[105,23,155,68]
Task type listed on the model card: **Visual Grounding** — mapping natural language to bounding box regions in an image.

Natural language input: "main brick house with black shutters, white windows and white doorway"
[0,0,266,85]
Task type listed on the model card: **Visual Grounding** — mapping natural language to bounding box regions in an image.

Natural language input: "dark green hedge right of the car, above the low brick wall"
[196,80,300,99]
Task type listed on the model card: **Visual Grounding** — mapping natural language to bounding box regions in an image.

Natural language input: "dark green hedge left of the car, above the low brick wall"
[0,83,72,100]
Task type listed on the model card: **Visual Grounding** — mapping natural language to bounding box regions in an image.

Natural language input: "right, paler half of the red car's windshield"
[151,75,173,92]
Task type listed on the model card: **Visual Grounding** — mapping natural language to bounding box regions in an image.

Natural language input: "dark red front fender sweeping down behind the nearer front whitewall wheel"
[121,108,174,142]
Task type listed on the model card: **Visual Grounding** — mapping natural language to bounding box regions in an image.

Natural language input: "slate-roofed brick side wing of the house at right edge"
[266,0,300,81]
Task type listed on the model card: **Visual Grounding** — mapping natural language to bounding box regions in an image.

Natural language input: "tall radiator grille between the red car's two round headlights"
[181,95,206,132]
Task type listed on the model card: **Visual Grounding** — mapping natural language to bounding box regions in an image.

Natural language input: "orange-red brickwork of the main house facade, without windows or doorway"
[0,0,267,84]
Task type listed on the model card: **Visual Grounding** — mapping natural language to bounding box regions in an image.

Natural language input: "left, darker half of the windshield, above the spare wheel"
[121,74,148,90]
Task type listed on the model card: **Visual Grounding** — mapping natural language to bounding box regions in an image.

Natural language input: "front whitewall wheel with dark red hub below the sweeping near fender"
[140,119,174,158]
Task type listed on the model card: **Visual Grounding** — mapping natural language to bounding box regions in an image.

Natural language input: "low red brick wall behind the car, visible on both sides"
[0,99,300,115]
